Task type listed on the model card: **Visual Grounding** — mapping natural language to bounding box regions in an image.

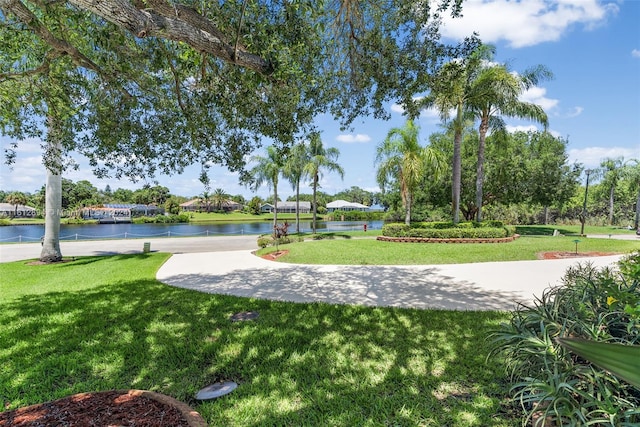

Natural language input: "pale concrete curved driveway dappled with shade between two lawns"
[156,250,621,310]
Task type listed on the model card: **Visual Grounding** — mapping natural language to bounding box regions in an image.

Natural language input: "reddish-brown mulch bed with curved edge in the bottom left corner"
[0,390,207,427]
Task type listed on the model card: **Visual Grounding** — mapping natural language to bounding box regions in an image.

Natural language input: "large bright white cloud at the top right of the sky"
[442,0,619,48]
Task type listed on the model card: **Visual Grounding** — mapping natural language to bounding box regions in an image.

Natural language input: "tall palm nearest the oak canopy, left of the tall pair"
[417,45,494,224]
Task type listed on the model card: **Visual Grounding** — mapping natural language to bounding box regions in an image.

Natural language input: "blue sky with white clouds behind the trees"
[0,0,640,200]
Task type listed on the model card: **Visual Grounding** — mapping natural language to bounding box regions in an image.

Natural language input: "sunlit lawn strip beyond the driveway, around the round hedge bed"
[258,236,640,265]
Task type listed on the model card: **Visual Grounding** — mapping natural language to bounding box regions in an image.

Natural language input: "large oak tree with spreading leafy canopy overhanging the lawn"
[0,0,473,261]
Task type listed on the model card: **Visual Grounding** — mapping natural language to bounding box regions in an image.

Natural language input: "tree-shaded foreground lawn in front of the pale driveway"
[0,254,519,427]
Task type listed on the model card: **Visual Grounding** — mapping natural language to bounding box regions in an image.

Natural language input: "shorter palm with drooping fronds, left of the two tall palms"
[376,120,442,225]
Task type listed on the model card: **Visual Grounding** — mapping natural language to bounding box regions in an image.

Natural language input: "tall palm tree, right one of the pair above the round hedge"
[468,61,552,222]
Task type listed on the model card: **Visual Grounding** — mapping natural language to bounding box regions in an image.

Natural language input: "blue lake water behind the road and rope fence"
[0,221,383,243]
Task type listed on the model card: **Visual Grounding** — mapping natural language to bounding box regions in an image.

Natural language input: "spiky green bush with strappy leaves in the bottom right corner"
[492,251,640,426]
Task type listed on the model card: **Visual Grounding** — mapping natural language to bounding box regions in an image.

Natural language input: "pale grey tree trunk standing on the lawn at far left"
[40,137,62,263]
